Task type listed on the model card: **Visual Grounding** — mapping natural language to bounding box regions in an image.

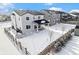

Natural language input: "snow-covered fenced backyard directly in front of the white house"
[19,30,61,55]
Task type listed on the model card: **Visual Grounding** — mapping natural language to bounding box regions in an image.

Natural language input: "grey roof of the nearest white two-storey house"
[15,10,44,16]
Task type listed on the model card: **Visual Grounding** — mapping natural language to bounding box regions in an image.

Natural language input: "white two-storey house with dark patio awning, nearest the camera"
[11,10,49,34]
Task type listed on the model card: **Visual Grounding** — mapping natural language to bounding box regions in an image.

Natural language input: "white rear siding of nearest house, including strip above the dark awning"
[21,13,44,34]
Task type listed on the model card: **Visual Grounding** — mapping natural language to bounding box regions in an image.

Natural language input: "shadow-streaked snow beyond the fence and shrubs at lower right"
[55,35,79,55]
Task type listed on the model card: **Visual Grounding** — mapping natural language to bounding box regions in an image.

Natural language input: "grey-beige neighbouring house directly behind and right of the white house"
[41,10,61,25]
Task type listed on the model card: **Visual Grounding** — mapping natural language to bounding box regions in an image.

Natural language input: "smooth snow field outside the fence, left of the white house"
[0,22,21,55]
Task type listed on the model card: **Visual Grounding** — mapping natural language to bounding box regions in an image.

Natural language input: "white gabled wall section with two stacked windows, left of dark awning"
[21,13,33,34]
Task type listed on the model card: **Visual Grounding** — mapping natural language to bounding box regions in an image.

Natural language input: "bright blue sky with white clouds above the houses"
[0,3,79,13]
